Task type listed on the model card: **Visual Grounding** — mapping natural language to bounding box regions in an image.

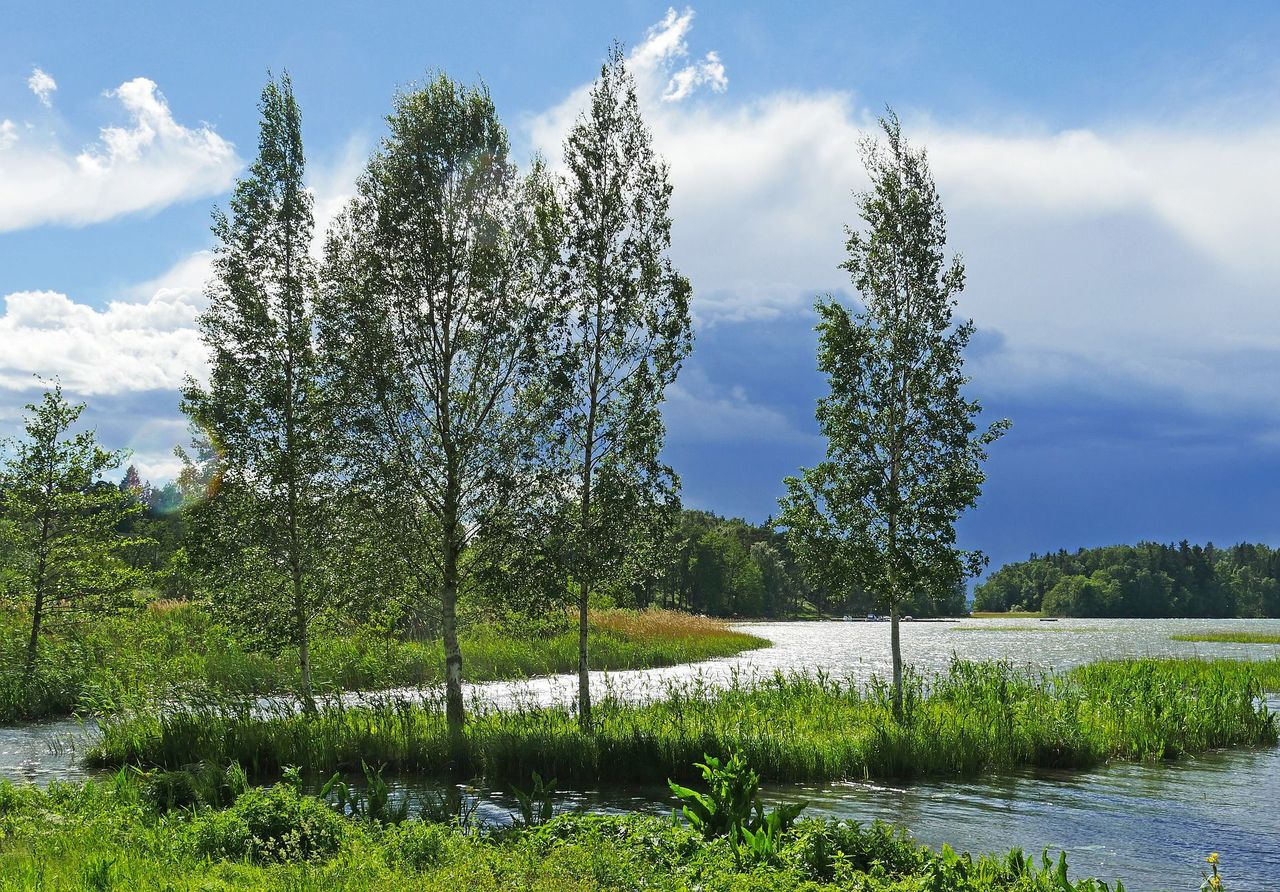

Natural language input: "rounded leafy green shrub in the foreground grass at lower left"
[192,783,346,863]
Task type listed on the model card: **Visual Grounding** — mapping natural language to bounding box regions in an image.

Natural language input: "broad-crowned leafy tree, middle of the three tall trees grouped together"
[320,74,557,742]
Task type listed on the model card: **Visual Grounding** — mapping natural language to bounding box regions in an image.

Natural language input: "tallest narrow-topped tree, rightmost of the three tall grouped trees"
[552,45,692,727]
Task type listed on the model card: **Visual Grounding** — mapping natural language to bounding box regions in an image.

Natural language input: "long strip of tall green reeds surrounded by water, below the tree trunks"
[90,660,1280,783]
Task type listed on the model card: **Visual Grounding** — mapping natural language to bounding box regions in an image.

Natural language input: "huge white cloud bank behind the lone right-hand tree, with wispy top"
[529,10,1280,417]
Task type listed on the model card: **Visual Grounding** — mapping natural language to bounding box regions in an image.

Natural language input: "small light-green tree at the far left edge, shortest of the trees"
[0,385,142,682]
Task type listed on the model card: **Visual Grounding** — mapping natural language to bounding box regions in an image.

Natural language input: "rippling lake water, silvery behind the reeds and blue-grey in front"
[0,619,1280,892]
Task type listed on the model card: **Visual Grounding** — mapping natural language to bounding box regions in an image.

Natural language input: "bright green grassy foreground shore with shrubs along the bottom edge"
[0,776,1121,892]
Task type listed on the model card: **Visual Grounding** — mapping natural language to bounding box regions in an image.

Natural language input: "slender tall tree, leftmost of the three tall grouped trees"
[183,74,333,710]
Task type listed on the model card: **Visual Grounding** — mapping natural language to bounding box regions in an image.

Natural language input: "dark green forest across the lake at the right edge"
[973,540,1280,617]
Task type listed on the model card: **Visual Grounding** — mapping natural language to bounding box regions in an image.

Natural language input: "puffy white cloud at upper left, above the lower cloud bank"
[0,78,241,232]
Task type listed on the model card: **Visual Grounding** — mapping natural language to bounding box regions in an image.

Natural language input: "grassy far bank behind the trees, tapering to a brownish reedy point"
[0,603,768,722]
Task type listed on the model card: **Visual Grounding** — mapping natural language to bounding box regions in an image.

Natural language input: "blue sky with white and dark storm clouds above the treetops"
[0,0,1280,566]
